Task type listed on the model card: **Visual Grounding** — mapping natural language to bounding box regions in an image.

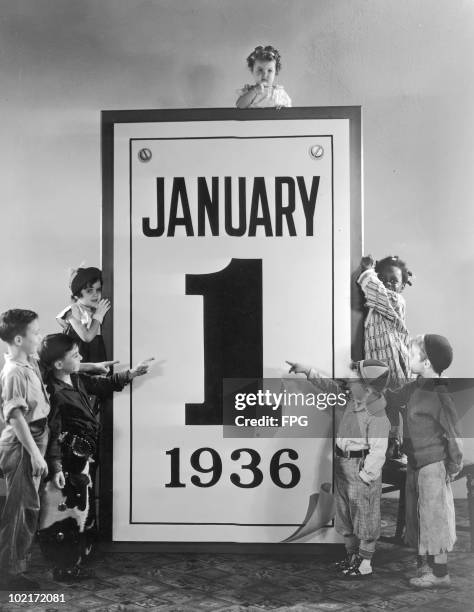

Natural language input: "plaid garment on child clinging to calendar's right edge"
[357,268,411,388]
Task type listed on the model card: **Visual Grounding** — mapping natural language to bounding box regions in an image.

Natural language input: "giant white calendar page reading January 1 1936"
[104,109,360,542]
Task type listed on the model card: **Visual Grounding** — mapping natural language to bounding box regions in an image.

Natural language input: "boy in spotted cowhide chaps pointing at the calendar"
[38,334,152,582]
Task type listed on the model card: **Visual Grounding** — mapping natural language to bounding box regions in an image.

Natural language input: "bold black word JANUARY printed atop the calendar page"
[142,176,320,238]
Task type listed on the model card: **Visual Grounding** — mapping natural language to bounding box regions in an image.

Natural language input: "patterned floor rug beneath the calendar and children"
[0,499,474,612]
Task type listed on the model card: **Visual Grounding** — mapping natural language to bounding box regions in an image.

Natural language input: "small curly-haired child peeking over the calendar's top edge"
[235,45,291,108]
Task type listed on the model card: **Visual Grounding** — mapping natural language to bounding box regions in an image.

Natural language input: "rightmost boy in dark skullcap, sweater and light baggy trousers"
[385,334,462,588]
